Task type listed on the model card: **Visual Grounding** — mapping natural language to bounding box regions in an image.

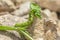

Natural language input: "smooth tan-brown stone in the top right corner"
[35,0,60,11]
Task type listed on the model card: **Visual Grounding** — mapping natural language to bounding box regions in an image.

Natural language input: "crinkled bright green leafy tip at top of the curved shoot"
[30,3,41,18]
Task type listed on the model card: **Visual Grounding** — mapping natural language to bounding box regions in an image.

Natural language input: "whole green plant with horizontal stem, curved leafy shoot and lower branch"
[0,3,41,40]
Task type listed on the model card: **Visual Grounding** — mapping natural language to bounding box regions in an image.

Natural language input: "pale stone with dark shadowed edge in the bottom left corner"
[0,31,21,40]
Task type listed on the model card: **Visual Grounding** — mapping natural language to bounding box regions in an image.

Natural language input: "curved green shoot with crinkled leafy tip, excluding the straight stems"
[15,3,41,27]
